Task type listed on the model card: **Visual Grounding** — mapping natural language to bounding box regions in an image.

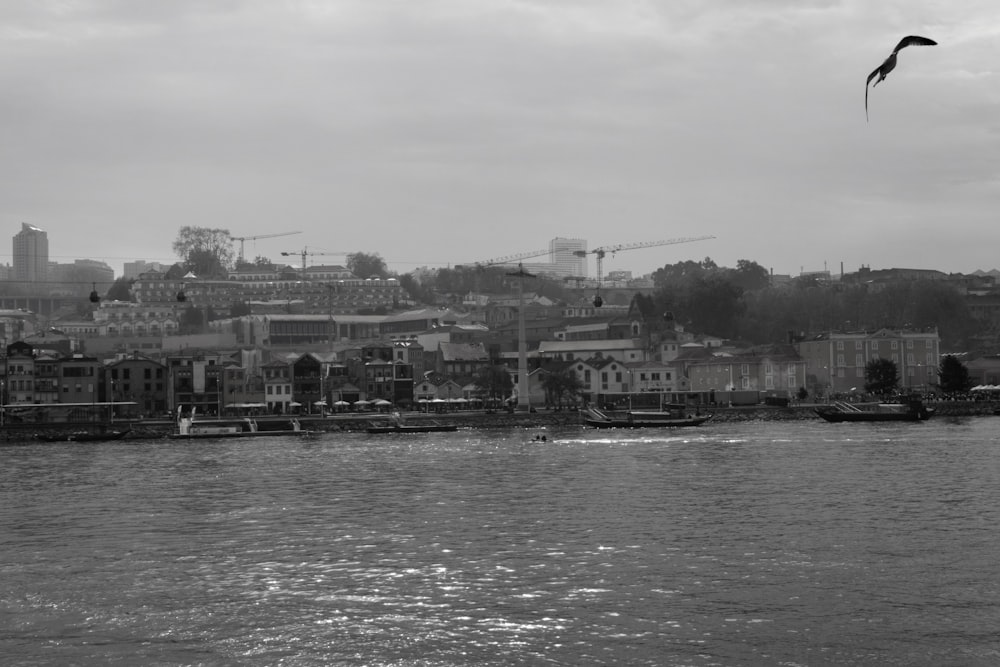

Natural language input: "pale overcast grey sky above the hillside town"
[0,0,1000,275]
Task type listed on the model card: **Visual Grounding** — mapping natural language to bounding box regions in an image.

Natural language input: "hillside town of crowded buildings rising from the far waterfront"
[0,224,1000,417]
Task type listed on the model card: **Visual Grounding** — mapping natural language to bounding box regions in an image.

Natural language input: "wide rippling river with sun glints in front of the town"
[0,417,1000,667]
